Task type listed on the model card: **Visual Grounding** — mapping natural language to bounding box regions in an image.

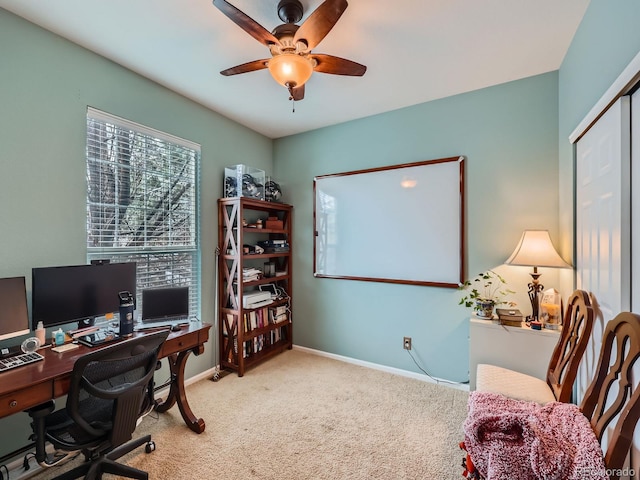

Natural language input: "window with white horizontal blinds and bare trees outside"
[86,108,200,316]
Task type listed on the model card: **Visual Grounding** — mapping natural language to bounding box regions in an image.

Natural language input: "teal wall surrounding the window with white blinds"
[0,9,272,456]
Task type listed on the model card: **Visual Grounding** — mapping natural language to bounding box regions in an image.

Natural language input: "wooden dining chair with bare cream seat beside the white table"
[476,290,595,404]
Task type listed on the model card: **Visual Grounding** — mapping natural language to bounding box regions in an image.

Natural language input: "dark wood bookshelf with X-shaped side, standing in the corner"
[218,197,293,376]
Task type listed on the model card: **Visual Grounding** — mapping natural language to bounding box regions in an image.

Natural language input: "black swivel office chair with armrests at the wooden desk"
[29,330,169,480]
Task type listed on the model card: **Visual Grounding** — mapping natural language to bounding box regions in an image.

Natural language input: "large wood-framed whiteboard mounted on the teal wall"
[313,157,464,288]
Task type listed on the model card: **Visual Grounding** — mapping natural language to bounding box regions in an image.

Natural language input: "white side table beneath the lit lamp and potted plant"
[469,317,560,390]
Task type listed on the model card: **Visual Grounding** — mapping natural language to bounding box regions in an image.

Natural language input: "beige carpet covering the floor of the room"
[36,349,468,480]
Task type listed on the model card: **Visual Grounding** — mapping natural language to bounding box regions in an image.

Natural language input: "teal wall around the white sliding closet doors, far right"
[558,0,640,266]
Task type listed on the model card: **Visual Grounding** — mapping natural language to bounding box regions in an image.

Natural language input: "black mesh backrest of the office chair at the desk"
[66,330,169,446]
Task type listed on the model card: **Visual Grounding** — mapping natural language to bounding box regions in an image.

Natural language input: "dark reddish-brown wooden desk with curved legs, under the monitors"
[0,323,211,433]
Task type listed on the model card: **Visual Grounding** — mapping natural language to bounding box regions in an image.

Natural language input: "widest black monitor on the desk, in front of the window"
[32,263,136,329]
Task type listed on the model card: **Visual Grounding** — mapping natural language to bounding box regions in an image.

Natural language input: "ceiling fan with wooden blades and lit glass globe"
[213,0,367,100]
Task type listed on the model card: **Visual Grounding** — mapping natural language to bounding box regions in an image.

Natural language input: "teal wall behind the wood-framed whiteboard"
[274,72,558,381]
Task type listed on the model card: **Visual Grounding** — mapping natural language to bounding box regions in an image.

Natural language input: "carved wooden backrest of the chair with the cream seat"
[547,290,595,402]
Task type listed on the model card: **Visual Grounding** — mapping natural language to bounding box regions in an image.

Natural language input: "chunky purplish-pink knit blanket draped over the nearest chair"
[464,392,608,480]
